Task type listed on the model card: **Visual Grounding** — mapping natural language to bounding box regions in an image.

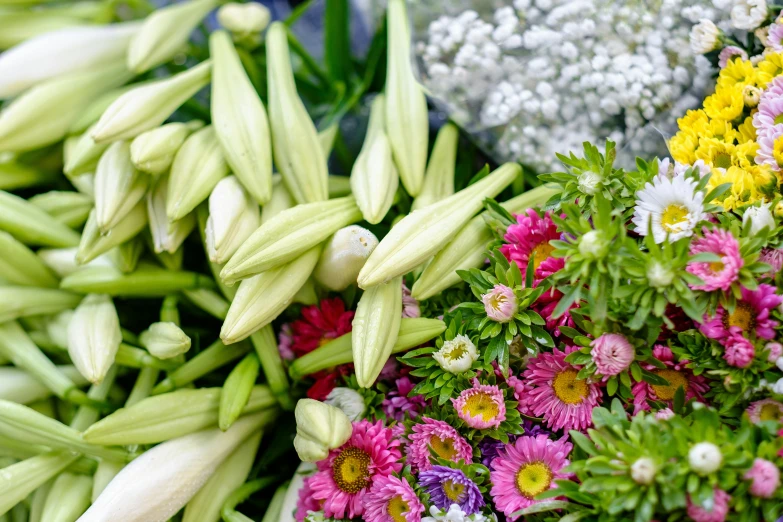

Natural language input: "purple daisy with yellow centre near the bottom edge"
[419,466,484,515]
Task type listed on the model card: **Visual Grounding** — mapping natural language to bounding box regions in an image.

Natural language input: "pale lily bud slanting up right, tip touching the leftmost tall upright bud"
[91,61,212,143]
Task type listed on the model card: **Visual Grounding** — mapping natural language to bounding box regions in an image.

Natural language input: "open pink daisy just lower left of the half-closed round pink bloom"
[520,347,601,430]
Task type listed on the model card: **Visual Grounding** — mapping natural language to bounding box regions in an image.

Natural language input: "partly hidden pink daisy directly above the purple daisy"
[406,417,473,471]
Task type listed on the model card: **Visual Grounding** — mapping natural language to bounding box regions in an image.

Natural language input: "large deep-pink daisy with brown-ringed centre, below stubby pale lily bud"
[310,420,402,518]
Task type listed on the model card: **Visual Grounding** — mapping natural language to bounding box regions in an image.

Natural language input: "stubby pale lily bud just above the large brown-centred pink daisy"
[294,399,352,462]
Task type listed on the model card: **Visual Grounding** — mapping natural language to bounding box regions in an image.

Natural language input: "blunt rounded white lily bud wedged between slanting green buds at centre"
[313,225,378,292]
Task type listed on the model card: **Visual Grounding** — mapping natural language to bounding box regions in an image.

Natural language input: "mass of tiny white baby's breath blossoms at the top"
[412,0,732,169]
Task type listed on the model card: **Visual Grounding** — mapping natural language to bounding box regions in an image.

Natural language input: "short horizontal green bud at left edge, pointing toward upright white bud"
[0,286,81,322]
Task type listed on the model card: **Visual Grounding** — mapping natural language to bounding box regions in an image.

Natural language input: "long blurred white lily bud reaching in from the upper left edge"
[0,23,140,98]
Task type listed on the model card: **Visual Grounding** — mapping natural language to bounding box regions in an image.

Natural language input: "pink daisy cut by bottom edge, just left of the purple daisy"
[362,475,424,522]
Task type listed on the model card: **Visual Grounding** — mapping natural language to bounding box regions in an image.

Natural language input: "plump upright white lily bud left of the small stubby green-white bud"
[68,294,122,384]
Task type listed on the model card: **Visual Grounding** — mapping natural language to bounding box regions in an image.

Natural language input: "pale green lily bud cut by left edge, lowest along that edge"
[0,451,79,514]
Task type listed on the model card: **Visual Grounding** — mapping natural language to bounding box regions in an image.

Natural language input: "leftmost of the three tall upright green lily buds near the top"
[209,29,272,205]
